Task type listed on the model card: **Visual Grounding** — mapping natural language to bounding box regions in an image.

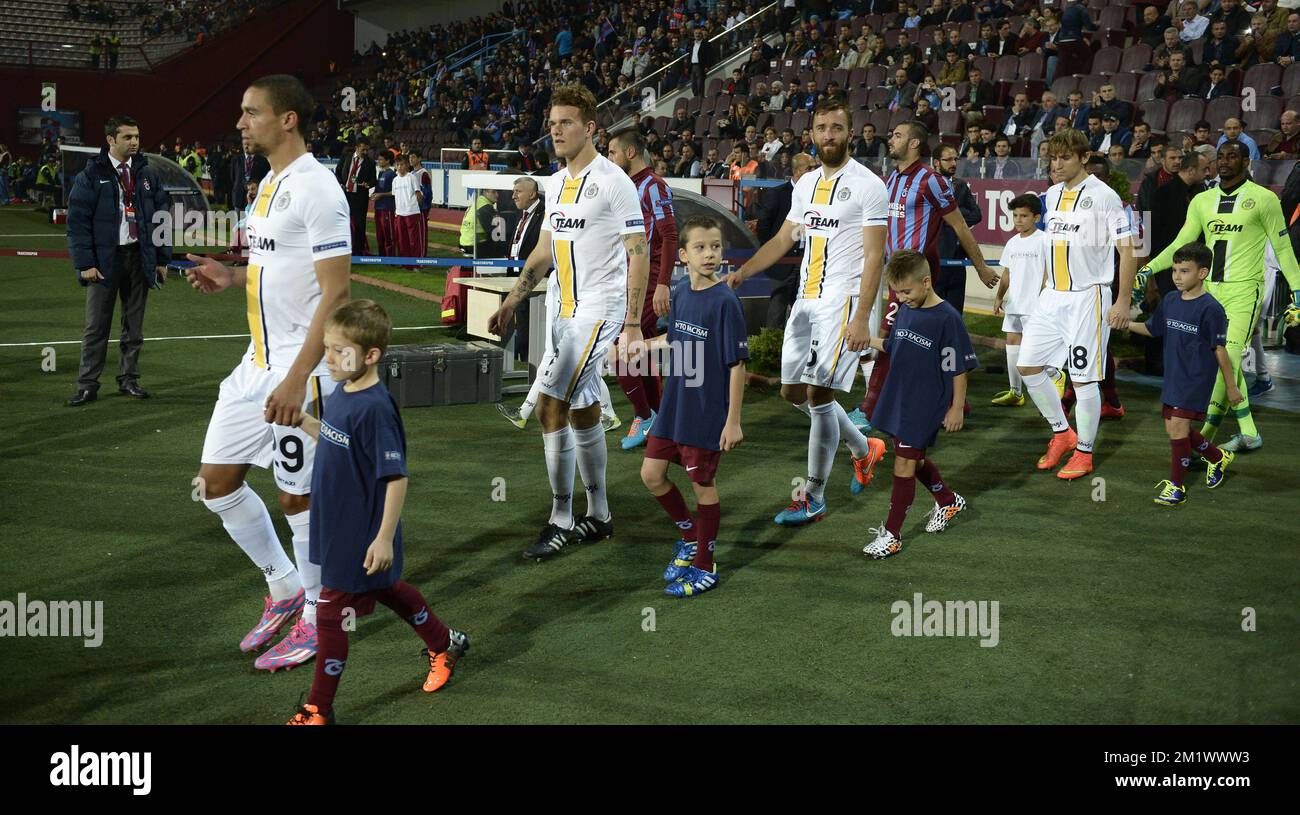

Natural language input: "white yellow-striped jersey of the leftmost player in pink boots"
[244,153,352,374]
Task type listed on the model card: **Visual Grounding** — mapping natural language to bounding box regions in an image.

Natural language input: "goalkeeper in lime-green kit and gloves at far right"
[1134,142,1300,452]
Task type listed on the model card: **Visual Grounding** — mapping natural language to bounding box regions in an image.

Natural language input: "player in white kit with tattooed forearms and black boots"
[488,84,650,559]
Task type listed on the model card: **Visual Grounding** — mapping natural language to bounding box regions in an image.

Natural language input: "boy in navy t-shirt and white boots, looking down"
[862,250,976,559]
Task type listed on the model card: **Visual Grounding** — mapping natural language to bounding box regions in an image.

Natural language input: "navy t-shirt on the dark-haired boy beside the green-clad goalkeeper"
[1147,291,1227,413]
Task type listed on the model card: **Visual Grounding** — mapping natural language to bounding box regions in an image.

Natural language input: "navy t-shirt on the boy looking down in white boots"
[868,302,979,447]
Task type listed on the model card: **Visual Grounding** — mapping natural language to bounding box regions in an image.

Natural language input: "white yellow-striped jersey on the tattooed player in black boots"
[546,155,649,320]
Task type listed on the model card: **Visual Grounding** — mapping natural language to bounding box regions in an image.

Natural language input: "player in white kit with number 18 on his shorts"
[1018,130,1138,480]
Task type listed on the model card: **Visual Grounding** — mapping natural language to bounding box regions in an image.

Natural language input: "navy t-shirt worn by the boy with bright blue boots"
[650,276,749,450]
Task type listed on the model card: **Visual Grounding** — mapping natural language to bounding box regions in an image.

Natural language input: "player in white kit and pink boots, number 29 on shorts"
[187,74,352,671]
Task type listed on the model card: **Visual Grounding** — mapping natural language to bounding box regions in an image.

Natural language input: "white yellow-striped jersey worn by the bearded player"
[785,159,889,300]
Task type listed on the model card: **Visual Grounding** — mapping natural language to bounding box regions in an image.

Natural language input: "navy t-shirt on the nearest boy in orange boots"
[311,383,407,593]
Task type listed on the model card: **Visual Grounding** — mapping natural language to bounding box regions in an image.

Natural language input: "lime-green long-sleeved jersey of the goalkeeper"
[1147,179,1300,290]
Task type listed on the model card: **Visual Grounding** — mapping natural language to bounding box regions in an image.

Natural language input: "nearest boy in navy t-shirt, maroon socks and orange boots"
[289,300,469,724]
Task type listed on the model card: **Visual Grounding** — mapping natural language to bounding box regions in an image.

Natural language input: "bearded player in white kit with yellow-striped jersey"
[727,100,889,526]
